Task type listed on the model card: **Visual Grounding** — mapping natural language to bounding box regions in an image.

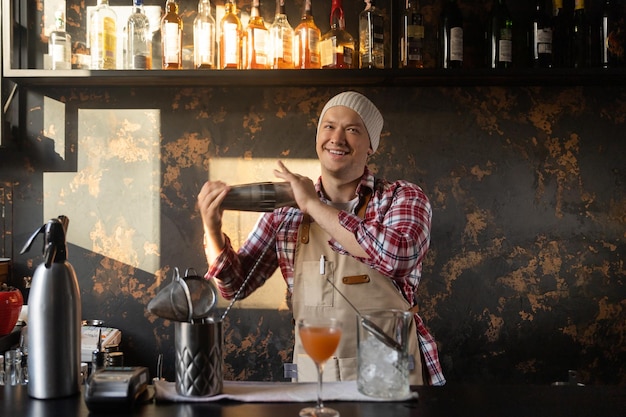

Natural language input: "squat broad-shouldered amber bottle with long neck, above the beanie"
[320,0,357,68]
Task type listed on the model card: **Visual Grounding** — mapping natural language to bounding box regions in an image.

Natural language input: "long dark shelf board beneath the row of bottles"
[4,68,626,87]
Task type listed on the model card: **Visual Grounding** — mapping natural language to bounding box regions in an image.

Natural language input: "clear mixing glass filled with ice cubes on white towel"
[357,310,413,400]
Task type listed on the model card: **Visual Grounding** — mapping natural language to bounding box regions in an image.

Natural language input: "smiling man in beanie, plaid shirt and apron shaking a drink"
[198,91,445,385]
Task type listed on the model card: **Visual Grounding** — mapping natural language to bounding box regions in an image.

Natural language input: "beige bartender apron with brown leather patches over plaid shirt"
[292,213,423,385]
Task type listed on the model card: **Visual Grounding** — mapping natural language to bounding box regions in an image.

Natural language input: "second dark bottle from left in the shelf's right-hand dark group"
[438,0,463,69]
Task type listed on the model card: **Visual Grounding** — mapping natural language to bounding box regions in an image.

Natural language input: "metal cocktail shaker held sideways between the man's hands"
[222,182,297,212]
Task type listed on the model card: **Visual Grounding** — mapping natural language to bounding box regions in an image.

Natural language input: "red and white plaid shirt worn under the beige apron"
[206,167,446,385]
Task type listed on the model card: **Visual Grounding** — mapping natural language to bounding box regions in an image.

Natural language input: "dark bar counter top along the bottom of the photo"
[0,384,626,417]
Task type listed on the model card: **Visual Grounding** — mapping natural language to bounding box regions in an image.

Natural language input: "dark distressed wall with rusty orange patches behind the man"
[0,2,626,384]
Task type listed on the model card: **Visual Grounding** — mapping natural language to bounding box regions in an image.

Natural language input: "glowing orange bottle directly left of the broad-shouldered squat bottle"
[294,0,322,69]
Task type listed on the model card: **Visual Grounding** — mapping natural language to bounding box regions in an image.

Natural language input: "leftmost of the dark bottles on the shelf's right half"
[398,0,424,68]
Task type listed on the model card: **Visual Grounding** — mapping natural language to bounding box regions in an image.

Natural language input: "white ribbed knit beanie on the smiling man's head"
[317,91,384,152]
